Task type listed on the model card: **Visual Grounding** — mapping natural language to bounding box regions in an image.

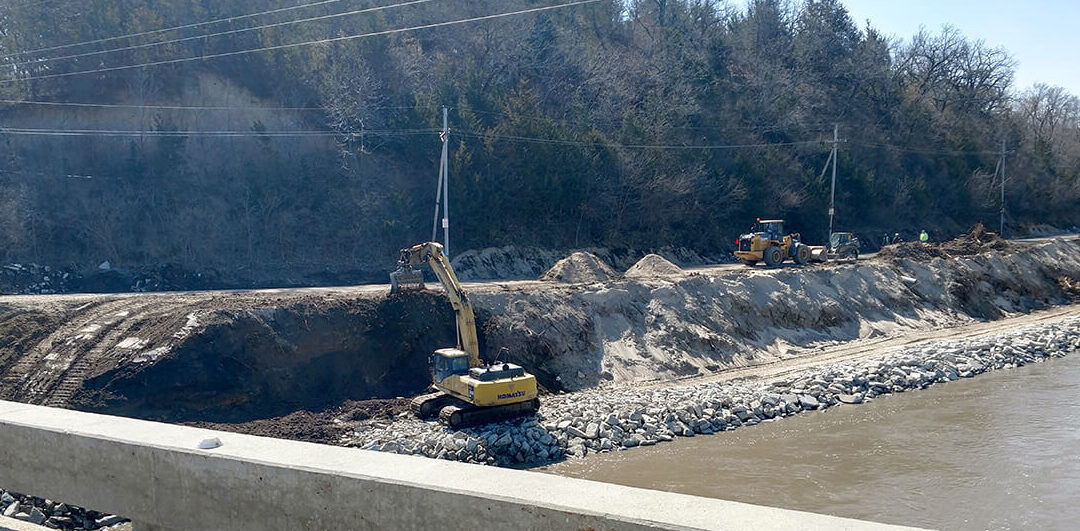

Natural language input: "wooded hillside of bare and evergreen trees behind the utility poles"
[0,0,1080,282]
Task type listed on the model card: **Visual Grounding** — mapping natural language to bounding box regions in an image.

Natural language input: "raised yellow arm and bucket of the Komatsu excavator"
[390,242,483,367]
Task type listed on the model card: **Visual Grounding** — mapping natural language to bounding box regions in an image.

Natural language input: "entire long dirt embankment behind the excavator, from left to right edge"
[0,234,1080,429]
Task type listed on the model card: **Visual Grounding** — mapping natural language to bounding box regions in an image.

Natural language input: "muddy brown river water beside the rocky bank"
[544,353,1080,529]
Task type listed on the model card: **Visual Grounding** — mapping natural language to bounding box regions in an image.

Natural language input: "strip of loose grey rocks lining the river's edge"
[341,317,1080,467]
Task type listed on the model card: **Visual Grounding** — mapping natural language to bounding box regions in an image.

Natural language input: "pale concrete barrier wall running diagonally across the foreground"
[0,401,920,530]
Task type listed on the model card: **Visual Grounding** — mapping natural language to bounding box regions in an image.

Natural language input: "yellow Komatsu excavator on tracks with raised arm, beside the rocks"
[390,242,540,428]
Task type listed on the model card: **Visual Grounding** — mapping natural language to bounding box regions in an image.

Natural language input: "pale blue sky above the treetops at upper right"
[841,0,1080,96]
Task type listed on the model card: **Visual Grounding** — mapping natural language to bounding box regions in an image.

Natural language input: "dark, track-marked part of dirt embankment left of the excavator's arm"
[0,291,455,422]
